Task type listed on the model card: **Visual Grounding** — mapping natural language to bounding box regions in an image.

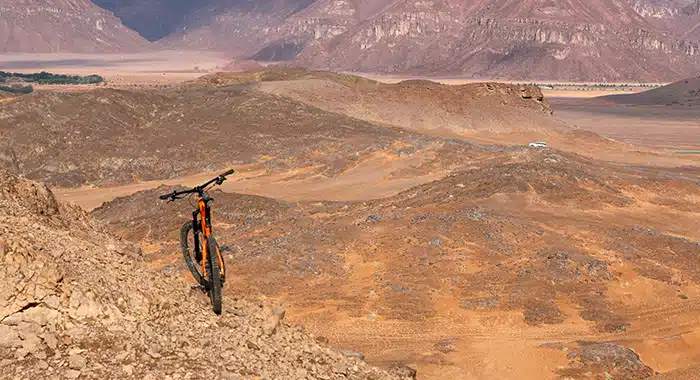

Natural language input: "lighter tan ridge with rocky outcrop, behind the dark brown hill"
[200,69,677,165]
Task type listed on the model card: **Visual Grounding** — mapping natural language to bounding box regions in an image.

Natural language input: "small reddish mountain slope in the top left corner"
[0,0,147,53]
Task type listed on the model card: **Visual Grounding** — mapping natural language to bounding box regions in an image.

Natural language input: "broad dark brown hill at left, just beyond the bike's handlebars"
[0,73,448,186]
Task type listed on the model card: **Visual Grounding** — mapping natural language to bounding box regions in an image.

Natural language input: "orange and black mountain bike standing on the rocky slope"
[160,169,234,314]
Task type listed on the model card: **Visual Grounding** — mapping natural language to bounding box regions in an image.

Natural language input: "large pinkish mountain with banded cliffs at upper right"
[297,0,700,81]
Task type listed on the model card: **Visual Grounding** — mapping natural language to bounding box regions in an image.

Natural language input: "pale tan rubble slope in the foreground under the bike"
[0,171,415,379]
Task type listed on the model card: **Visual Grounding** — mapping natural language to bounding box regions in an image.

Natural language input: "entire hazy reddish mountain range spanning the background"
[0,0,700,82]
